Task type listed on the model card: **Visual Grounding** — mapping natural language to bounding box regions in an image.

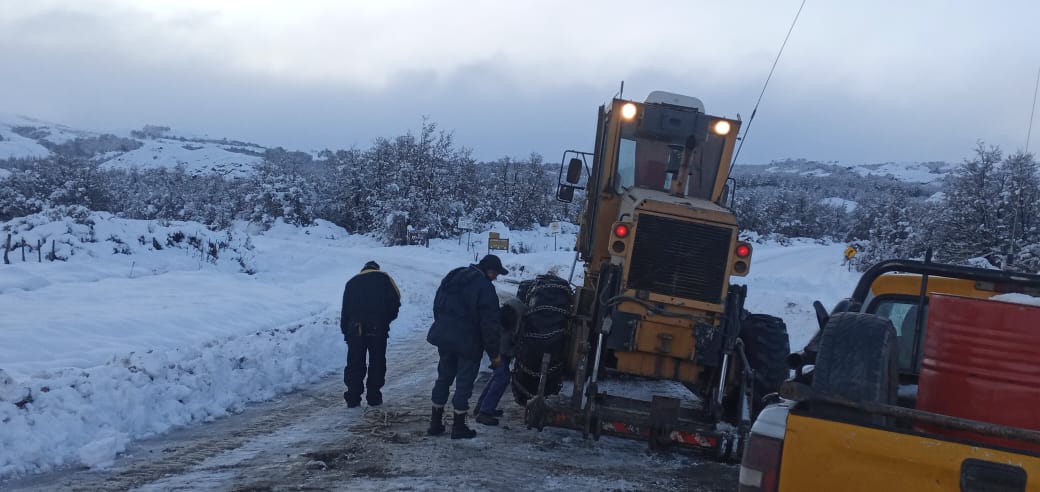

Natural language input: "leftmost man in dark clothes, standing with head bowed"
[339,261,400,408]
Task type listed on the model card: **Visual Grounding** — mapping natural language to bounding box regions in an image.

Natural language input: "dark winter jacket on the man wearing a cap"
[426,265,502,360]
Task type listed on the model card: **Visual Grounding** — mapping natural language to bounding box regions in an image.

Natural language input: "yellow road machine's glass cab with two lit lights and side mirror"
[556,90,740,264]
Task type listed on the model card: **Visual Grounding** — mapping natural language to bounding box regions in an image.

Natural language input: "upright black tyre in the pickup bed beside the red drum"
[812,313,899,425]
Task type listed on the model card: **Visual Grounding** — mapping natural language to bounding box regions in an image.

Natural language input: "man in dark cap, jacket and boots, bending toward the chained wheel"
[426,255,509,439]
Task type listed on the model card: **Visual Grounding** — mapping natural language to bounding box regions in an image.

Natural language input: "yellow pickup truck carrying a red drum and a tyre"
[739,260,1040,492]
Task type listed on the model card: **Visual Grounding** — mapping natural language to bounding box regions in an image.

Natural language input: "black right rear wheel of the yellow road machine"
[740,314,790,413]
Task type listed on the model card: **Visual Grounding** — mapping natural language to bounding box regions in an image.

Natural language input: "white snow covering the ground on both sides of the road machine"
[0,213,857,478]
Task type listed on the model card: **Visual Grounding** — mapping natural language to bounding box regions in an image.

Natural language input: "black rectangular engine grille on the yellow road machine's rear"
[628,214,733,304]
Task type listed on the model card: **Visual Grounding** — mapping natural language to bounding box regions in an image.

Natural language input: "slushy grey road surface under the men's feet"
[3,312,737,491]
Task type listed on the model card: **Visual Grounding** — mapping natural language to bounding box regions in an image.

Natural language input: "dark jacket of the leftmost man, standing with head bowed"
[339,269,400,340]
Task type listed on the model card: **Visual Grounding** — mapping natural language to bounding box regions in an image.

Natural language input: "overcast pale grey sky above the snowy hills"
[0,0,1040,163]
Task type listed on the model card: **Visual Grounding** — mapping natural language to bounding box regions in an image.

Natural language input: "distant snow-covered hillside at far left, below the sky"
[0,113,267,176]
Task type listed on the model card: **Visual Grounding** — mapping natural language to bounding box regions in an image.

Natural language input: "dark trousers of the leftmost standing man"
[343,335,387,405]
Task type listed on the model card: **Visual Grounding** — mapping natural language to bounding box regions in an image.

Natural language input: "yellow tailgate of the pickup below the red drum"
[780,414,1040,492]
